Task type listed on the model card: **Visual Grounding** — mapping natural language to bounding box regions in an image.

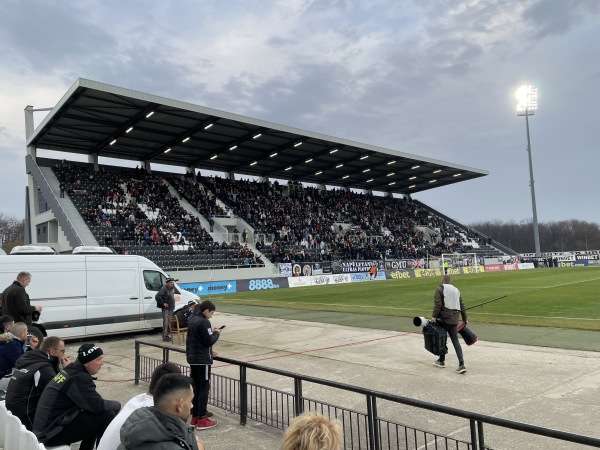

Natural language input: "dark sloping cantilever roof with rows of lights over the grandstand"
[27,78,488,193]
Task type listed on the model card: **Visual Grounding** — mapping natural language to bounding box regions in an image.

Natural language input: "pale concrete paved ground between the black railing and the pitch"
[62,310,600,450]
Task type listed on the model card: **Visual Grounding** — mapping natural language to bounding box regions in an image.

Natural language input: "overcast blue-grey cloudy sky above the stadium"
[0,0,600,223]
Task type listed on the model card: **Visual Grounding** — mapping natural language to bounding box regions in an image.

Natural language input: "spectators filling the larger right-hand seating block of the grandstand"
[185,177,476,262]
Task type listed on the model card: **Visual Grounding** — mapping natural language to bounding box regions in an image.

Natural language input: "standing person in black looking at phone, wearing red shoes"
[185,300,221,429]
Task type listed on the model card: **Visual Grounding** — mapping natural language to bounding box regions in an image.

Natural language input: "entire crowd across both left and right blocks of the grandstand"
[53,162,482,265]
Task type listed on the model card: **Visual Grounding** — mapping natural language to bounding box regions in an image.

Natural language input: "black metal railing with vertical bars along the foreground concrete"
[135,340,600,450]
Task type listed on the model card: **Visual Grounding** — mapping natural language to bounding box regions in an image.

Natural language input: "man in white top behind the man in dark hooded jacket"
[97,363,181,450]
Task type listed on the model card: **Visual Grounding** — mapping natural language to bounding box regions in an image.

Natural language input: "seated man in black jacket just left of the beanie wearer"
[6,336,71,431]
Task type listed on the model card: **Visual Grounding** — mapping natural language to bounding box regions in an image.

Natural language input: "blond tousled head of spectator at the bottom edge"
[281,413,344,450]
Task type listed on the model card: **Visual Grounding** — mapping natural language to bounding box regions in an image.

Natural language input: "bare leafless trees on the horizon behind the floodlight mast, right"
[469,219,600,253]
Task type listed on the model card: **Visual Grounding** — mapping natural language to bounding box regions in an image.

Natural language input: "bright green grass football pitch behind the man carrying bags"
[220,267,600,330]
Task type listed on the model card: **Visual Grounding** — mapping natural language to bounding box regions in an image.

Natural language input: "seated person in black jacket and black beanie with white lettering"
[33,344,121,450]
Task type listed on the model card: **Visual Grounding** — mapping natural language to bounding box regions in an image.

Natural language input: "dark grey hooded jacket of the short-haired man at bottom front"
[118,407,198,450]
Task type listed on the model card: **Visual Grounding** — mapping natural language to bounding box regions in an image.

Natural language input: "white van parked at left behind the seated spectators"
[0,255,198,339]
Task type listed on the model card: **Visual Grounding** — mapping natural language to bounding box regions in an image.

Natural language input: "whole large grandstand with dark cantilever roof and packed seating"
[25,79,516,281]
